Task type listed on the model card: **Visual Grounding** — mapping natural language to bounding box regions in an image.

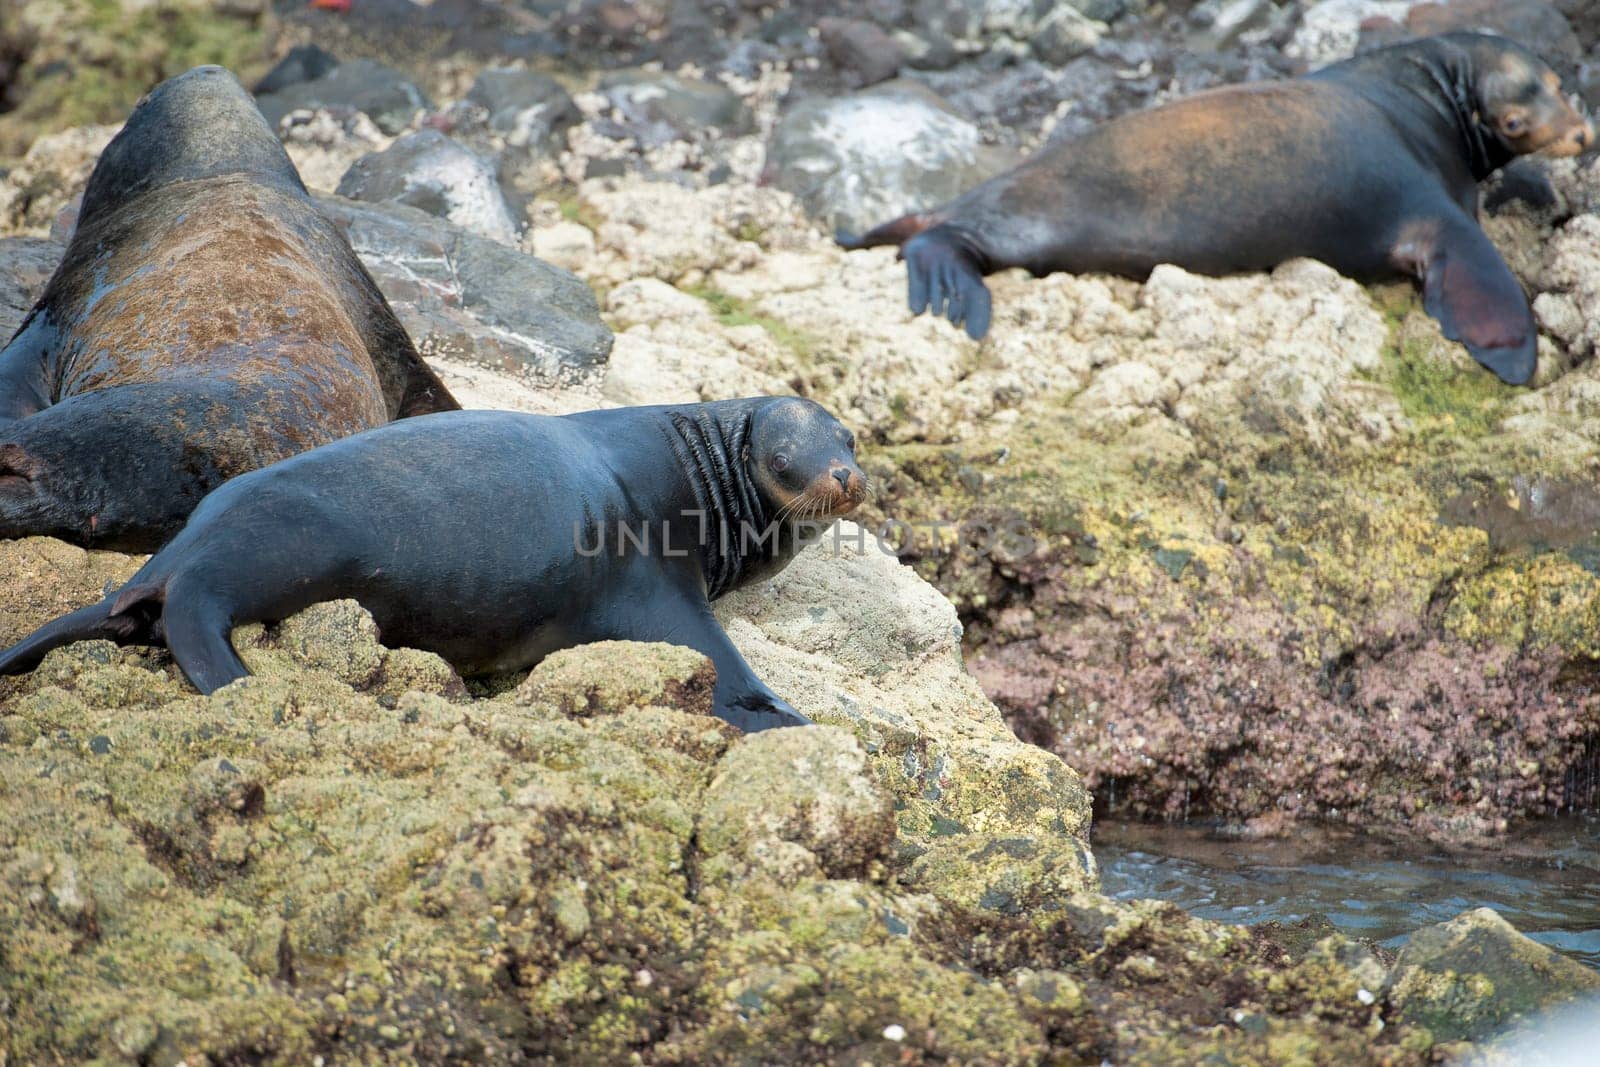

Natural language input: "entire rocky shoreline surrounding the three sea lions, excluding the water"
[0,0,1600,1064]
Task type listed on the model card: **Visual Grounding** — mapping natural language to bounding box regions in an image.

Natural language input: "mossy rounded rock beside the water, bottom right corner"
[1387,907,1600,1041]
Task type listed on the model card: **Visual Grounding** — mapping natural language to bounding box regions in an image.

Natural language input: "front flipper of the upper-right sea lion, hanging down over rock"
[1394,218,1539,386]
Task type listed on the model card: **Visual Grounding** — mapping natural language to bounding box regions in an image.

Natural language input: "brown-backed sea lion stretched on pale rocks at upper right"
[840,34,1594,384]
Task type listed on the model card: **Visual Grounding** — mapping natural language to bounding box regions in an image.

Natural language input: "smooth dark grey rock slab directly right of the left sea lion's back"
[318,197,611,386]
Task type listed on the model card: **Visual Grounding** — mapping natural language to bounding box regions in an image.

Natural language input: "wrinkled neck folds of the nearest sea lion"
[662,400,771,600]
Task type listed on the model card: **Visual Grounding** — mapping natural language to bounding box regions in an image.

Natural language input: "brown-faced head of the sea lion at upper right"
[1464,34,1595,155]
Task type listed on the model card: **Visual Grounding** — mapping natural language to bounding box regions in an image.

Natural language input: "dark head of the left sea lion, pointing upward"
[78,67,306,226]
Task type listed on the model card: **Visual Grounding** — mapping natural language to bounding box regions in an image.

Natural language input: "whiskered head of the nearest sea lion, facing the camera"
[746,397,867,520]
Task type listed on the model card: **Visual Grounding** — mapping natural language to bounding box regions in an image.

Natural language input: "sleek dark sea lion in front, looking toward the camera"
[0,397,867,729]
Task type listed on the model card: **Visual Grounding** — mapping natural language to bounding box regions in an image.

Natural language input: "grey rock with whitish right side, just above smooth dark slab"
[338,130,520,245]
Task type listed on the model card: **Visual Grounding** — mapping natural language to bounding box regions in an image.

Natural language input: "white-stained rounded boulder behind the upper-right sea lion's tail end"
[766,80,1014,232]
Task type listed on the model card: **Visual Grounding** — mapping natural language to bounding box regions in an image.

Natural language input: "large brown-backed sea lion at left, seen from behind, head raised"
[0,67,459,552]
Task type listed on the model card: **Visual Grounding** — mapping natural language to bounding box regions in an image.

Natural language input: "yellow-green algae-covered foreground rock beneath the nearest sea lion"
[9,528,1565,1064]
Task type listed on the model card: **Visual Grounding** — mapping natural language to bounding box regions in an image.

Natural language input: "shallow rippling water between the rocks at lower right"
[1093,814,1600,969]
